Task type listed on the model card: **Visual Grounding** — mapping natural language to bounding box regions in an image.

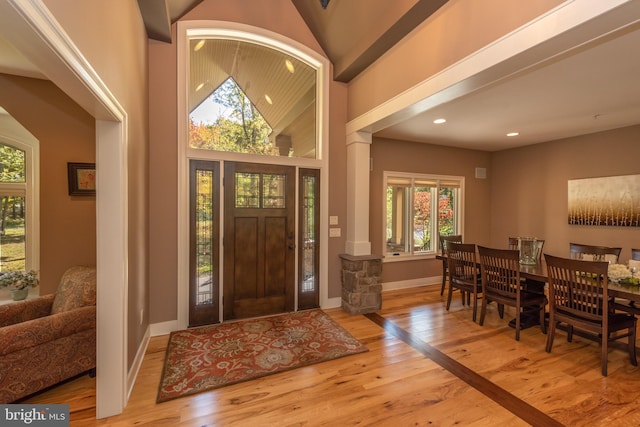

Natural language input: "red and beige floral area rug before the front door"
[157,309,368,402]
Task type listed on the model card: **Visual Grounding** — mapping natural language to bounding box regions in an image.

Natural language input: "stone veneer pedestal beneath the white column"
[340,254,382,314]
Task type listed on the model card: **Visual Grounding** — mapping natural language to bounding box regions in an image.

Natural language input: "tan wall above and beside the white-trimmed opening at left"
[43,0,149,366]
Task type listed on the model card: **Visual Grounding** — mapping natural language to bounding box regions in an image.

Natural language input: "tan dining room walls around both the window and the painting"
[370,126,640,283]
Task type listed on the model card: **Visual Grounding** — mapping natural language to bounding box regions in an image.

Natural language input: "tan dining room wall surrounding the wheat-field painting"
[488,126,640,261]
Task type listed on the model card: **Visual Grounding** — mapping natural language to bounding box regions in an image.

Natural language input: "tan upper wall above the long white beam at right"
[348,0,564,120]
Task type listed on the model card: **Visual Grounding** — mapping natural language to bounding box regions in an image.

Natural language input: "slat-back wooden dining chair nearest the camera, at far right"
[545,254,638,377]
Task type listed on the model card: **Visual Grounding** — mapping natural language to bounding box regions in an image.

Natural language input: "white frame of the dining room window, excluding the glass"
[381,171,465,262]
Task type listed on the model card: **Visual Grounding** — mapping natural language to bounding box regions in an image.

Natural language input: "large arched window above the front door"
[187,35,319,159]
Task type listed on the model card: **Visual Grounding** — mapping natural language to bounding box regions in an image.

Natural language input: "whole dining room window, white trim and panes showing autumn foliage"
[383,172,464,258]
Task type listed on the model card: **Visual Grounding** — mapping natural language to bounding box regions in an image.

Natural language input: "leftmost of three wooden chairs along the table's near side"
[447,242,482,322]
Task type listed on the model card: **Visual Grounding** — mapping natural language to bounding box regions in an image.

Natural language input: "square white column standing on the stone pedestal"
[345,132,371,256]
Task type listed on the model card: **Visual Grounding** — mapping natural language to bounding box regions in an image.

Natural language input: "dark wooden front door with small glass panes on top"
[223,162,296,320]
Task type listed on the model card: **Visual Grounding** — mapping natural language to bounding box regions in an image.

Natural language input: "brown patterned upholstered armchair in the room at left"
[0,267,96,403]
